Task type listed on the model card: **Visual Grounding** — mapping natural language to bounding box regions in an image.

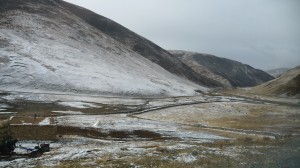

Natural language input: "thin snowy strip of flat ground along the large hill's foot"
[0,90,211,109]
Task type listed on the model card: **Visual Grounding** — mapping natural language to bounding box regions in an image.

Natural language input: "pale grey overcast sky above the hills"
[66,0,300,70]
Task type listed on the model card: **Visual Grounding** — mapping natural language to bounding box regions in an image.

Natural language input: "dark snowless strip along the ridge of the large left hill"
[56,0,220,87]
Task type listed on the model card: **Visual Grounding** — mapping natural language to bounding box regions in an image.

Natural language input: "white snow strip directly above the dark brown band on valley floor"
[57,114,226,141]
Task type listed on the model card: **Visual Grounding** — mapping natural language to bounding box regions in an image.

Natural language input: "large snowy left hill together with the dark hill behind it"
[0,0,273,96]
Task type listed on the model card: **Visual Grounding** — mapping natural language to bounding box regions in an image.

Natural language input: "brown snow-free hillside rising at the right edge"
[251,66,300,98]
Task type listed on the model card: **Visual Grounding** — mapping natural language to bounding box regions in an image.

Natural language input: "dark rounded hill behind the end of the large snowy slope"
[169,51,274,87]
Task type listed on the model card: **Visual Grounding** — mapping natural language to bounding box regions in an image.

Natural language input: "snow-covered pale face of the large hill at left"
[0,0,204,96]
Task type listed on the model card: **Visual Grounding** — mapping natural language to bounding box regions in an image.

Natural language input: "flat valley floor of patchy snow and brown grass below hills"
[0,93,300,167]
